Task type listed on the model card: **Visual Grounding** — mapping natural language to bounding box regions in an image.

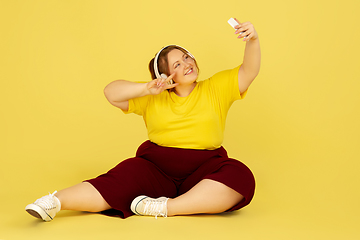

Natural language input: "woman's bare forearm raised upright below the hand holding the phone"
[242,38,261,77]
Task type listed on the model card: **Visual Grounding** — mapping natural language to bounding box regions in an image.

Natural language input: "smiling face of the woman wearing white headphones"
[168,49,198,84]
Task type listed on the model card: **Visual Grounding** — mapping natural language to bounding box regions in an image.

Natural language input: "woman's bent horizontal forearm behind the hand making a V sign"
[104,80,150,102]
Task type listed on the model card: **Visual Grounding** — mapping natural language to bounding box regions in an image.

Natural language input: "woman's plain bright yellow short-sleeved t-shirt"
[125,66,246,149]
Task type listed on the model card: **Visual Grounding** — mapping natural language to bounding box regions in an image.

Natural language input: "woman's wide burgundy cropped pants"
[87,141,255,218]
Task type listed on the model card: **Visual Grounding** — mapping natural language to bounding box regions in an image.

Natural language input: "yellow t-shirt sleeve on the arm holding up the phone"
[210,65,247,104]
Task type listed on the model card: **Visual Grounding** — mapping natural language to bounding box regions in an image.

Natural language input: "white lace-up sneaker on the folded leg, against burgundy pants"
[130,195,169,218]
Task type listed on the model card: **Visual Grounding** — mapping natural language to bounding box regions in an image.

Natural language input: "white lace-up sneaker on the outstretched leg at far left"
[25,191,61,222]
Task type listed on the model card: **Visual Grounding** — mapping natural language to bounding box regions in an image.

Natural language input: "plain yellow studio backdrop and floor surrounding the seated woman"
[0,0,360,240]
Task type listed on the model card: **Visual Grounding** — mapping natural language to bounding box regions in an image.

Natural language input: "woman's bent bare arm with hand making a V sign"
[104,74,177,111]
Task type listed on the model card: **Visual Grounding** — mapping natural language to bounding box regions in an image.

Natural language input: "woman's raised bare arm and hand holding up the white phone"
[235,20,261,93]
